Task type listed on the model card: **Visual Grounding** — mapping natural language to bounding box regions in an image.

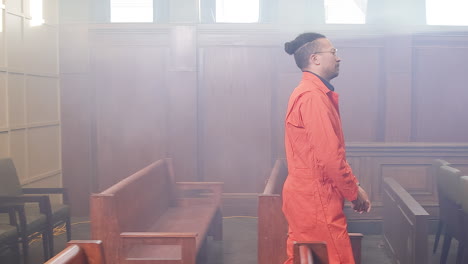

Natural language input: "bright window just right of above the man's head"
[324,0,367,24]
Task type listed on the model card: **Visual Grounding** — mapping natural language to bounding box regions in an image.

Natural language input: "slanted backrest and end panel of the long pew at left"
[90,159,174,260]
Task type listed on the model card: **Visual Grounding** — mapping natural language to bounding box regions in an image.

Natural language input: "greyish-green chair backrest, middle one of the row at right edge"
[439,165,462,203]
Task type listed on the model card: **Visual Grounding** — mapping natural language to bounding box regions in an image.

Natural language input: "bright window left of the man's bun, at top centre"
[216,0,260,23]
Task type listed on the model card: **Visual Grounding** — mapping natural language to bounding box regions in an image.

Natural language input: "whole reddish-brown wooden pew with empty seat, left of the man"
[90,159,222,264]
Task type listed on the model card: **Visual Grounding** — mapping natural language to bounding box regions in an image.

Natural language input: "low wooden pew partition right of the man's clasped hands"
[383,178,429,264]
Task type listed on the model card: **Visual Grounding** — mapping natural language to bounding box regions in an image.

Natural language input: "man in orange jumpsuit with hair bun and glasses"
[283,33,371,264]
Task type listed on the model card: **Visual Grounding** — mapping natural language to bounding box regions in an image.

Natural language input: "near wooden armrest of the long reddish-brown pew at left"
[120,232,198,264]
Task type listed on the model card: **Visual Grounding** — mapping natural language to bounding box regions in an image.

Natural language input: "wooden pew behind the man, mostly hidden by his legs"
[258,159,363,264]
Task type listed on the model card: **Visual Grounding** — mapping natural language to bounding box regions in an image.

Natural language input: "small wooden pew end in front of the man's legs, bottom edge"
[293,242,328,264]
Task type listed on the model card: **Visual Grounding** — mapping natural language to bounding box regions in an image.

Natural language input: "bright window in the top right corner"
[426,0,468,26]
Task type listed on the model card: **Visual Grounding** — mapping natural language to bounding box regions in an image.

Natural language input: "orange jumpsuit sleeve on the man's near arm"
[300,95,358,201]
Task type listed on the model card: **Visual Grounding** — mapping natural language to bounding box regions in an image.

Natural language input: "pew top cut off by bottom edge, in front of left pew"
[45,240,106,264]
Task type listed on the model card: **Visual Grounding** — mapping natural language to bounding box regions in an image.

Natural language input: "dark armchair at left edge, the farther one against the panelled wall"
[0,158,71,262]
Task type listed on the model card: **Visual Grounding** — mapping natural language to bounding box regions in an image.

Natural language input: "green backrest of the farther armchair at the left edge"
[0,158,23,196]
